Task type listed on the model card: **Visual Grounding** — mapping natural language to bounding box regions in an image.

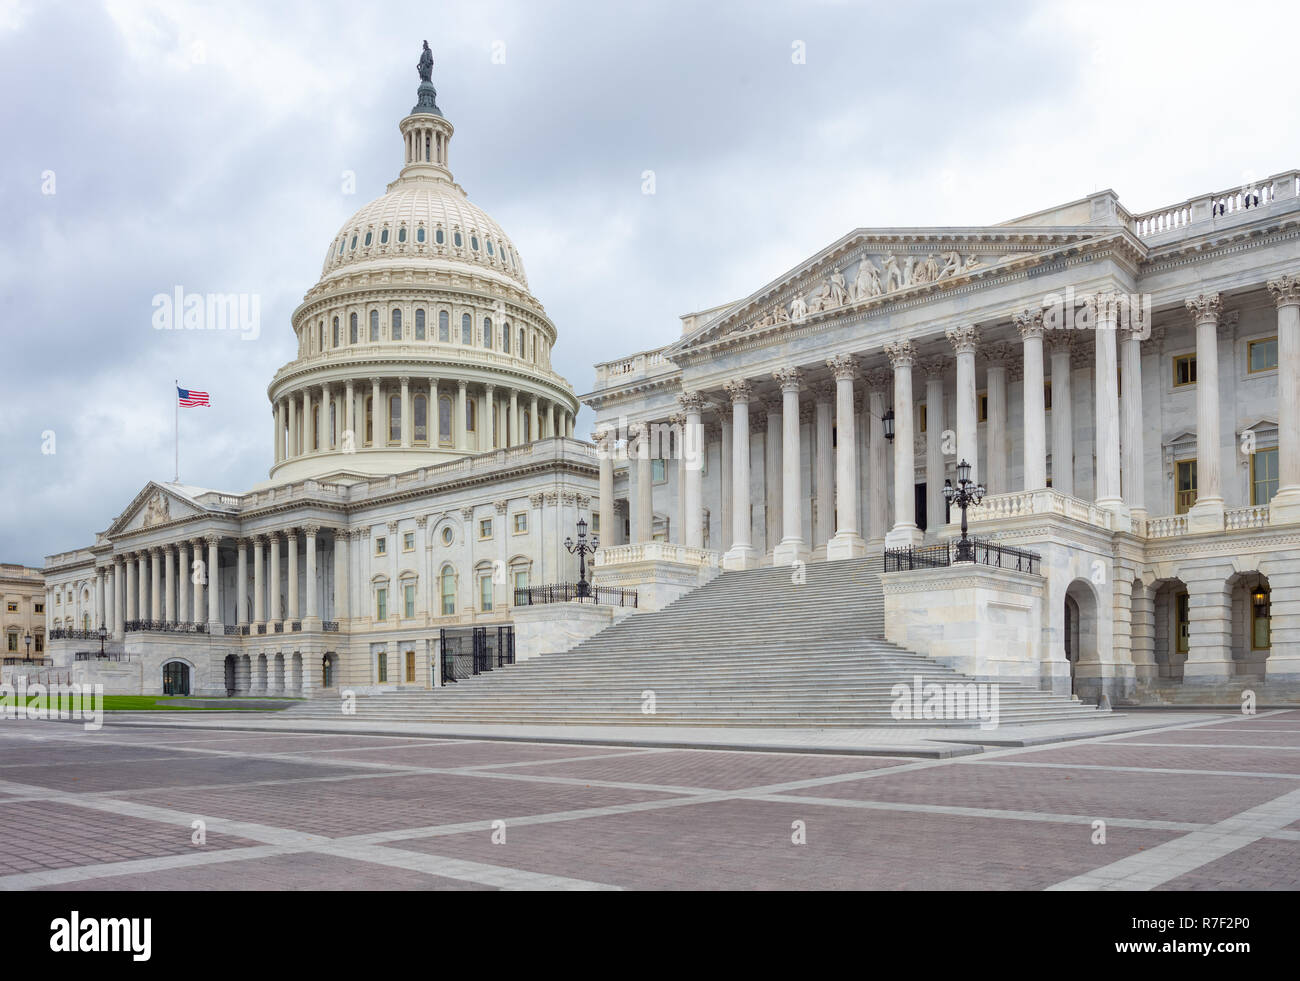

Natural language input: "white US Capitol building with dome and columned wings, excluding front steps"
[35,48,1300,700]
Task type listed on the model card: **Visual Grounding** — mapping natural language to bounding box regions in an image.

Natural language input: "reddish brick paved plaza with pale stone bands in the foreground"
[0,711,1300,890]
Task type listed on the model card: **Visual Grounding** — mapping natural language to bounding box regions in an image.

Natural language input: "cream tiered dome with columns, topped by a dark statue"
[267,50,579,483]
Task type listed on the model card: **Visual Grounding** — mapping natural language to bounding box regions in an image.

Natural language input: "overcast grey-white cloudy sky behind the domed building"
[0,0,1300,565]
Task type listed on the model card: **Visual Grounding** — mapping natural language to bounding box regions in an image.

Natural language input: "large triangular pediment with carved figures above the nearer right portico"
[664,226,1123,359]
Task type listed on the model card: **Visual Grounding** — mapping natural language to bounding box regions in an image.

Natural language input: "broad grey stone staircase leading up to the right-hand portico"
[285,557,1105,726]
